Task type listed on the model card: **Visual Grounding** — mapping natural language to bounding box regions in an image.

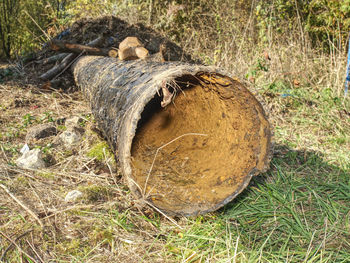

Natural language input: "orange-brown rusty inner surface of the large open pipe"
[132,74,271,214]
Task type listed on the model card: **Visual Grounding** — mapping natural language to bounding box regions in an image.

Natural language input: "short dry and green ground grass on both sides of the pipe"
[0,67,350,262]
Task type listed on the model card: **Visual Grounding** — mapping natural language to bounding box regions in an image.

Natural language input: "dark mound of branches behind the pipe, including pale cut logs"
[35,16,193,87]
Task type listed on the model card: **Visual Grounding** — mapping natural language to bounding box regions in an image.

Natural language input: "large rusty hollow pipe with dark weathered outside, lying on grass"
[73,56,272,215]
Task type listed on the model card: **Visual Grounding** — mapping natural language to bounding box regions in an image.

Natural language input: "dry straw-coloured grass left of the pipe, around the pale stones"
[0,85,171,262]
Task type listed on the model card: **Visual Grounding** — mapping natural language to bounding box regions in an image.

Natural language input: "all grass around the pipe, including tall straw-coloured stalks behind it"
[0,1,350,263]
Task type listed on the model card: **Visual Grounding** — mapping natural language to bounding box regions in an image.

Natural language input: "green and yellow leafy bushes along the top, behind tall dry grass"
[0,0,350,57]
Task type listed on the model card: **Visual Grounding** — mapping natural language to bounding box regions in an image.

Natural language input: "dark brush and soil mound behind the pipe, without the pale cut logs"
[28,16,192,91]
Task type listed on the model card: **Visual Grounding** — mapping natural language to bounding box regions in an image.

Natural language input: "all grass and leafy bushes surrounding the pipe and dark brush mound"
[0,0,350,263]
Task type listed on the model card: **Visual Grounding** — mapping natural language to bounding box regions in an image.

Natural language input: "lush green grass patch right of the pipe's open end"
[161,149,350,262]
